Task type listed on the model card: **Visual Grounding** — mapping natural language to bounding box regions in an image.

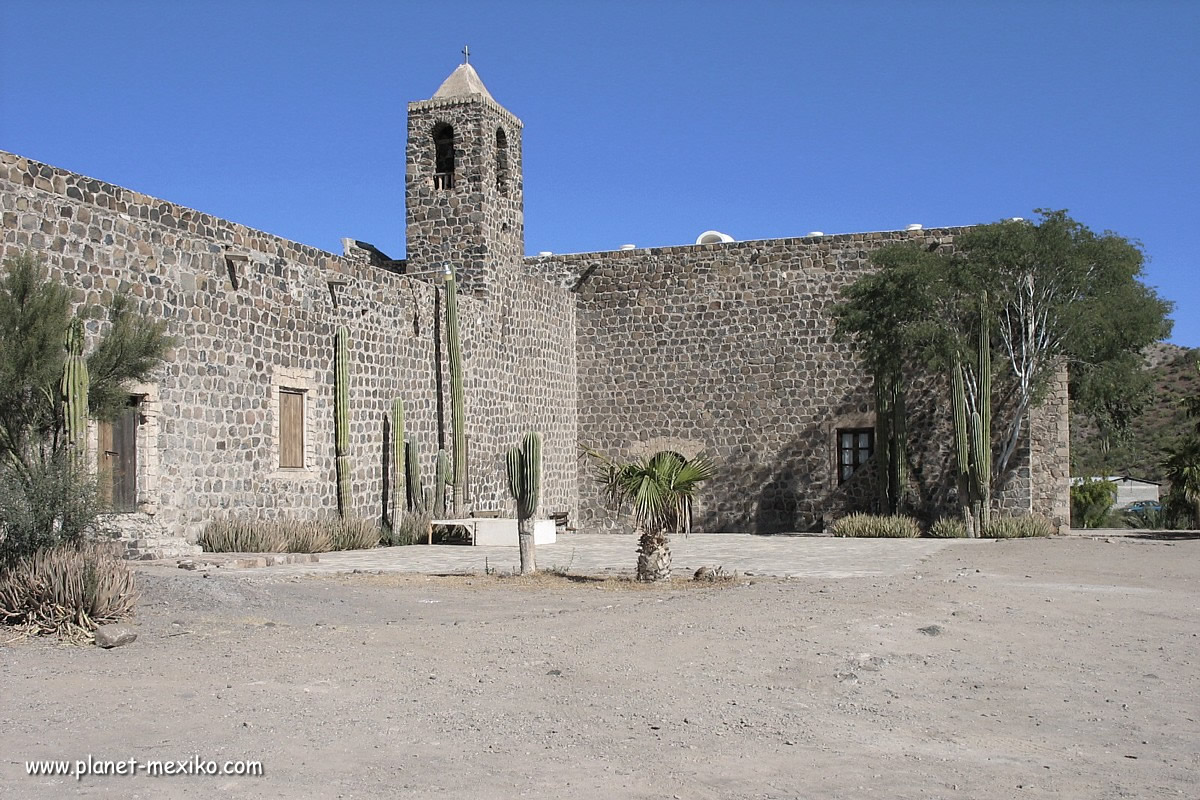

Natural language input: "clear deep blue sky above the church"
[0,0,1200,347]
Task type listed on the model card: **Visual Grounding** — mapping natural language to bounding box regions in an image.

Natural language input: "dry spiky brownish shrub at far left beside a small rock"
[0,541,137,636]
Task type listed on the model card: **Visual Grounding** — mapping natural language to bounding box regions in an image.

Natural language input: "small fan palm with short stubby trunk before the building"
[587,450,713,581]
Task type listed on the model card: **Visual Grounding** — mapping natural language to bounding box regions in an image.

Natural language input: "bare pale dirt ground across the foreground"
[0,539,1200,800]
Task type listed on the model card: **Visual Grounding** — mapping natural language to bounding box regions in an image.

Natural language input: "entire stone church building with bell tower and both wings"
[0,64,1069,556]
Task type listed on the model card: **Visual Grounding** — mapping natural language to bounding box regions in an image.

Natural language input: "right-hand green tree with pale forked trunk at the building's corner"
[956,210,1170,474]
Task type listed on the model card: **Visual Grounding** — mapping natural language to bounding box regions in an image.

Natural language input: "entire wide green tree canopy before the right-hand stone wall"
[835,210,1170,520]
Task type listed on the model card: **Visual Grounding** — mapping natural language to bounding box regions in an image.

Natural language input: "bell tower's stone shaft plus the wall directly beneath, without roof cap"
[404,94,577,518]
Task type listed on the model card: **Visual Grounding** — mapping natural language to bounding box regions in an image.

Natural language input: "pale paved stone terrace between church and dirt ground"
[223,534,952,578]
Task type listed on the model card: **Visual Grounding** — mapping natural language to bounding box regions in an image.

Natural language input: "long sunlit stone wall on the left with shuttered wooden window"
[0,152,577,540]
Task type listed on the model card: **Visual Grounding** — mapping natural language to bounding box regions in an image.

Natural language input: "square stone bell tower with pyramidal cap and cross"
[404,55,524,295]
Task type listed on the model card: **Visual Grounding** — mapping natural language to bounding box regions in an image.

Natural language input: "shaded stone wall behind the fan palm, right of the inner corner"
[526,229,1066,533]
